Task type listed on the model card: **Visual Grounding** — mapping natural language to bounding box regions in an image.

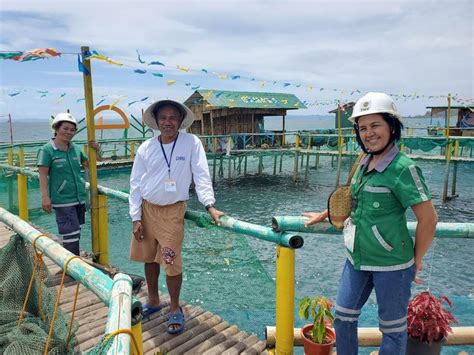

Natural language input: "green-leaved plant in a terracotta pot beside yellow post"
[299,296,336,354]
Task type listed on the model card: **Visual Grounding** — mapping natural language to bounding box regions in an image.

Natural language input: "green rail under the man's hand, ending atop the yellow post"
[185,211,304,249]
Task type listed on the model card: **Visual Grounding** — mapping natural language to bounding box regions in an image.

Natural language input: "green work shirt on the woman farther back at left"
[37,140,87,207]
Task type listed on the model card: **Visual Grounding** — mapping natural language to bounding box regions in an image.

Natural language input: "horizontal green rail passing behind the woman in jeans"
[272,216,474,239]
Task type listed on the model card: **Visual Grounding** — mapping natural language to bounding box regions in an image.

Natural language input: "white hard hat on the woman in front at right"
[349,92,402,123]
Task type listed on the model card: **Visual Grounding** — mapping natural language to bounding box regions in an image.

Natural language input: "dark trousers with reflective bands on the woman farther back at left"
[54,204,86,244]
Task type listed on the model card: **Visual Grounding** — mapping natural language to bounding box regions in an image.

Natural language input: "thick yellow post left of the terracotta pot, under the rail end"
[275,245,295,355]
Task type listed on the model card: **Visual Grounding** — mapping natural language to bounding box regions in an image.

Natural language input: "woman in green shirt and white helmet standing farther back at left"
[37,113,99,255]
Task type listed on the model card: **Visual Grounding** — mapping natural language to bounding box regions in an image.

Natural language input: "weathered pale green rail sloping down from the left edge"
[0,207,141,324]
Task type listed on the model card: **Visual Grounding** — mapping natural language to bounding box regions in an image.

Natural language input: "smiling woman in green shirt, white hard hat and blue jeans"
[304,92,438,355]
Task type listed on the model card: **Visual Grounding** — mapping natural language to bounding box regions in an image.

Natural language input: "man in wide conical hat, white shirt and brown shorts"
[129,99,224,334]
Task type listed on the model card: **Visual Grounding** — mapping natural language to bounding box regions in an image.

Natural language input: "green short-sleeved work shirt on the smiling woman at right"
[346,152,431,271]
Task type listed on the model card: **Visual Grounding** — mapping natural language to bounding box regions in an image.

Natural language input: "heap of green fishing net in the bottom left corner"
[0,235,77,355]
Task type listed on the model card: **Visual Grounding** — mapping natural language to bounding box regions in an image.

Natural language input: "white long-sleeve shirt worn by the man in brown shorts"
[128,132,216,221]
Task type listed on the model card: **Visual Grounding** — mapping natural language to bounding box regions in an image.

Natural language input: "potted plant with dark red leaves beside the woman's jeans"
[406,291,456,355]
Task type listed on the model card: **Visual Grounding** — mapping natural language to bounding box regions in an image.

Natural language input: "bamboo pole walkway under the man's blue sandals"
[0,222,267,355]
